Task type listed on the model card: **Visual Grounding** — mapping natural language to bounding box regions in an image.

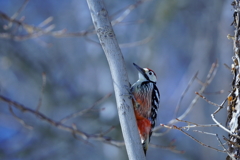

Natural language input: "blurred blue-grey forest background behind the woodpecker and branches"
[0,0,233,160]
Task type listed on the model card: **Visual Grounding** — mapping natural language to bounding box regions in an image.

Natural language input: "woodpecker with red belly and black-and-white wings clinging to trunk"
[130,63,160,155]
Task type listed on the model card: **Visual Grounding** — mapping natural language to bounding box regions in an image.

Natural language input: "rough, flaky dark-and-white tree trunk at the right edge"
[227,0,240,160]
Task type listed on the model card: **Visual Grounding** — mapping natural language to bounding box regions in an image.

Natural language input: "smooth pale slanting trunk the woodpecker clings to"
[87,0,146,160]
